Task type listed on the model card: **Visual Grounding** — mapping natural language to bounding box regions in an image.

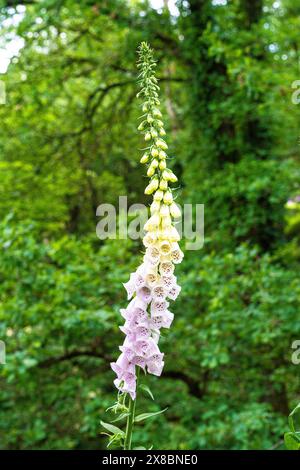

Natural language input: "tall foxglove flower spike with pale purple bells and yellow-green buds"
[111,43,183,400]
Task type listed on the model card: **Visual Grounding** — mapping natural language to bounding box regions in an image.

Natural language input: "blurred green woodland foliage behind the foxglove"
[0,0,300,449]
